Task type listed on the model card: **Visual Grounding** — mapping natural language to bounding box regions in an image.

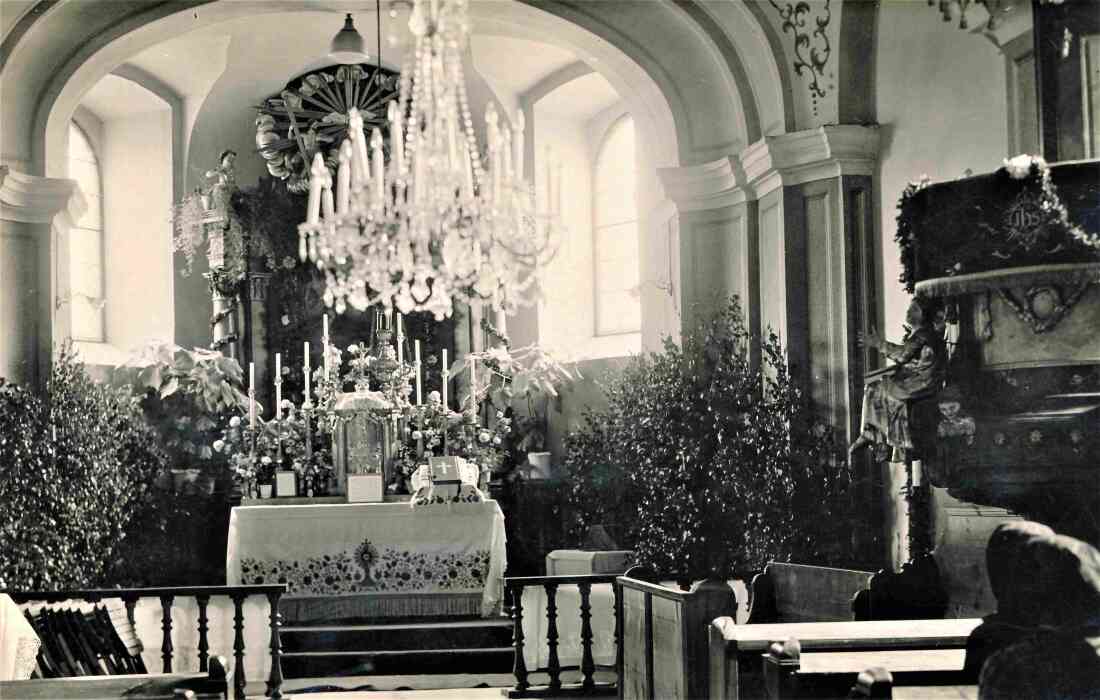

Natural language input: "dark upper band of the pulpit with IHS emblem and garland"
[894,154,1100,294]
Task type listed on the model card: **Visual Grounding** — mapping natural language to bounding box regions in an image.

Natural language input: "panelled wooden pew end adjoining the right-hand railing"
[616,569,737,700]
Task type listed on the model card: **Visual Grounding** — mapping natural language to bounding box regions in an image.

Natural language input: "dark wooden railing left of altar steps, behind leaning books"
[7,583,286,700]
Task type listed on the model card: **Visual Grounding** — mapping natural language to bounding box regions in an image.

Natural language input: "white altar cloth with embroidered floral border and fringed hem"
[226,501,507,621]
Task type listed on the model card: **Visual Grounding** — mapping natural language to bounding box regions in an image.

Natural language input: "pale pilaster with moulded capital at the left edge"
[0,165,85,383]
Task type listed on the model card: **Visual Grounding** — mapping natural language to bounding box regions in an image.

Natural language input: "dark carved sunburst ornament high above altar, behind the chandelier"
[255,65,399,193]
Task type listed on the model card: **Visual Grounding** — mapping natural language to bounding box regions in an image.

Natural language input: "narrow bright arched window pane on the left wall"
[68,122,107,342]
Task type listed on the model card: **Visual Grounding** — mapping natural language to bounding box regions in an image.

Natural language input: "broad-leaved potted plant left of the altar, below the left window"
[114,342,249,493]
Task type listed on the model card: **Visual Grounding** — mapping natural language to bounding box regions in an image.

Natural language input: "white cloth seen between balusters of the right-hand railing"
[523,583,615,671]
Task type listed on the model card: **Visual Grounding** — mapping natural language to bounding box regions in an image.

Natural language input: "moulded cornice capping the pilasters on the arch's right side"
[658,124,879,211]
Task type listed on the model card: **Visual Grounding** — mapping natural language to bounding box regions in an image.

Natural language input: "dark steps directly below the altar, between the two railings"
[279,617,513,678]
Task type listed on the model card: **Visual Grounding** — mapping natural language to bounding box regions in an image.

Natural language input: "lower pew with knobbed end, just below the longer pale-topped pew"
[762,639,975,700]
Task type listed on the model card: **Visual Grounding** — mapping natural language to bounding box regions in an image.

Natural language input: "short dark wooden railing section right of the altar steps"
[504,573,623,698]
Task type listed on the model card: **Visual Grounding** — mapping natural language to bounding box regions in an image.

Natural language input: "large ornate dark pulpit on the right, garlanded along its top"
[900,156,1100,614]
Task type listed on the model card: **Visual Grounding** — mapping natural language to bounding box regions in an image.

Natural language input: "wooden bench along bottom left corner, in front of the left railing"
[0,656,229,700]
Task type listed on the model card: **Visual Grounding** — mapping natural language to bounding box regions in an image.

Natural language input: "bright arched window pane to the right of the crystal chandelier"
[593,116,641,336]
